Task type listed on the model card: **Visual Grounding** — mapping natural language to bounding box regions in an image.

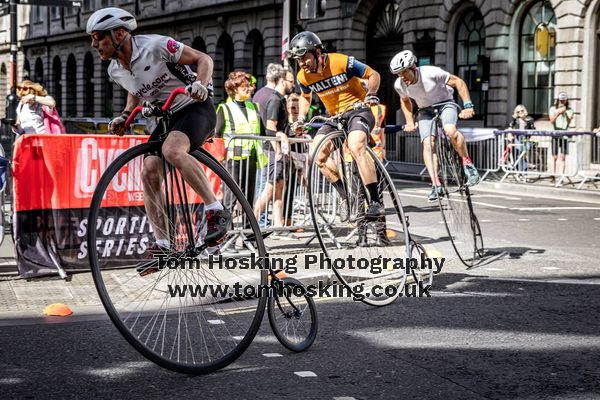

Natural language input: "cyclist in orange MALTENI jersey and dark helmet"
[288,31,388,245]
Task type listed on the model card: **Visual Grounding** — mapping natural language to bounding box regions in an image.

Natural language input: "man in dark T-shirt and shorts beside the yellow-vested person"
[254,69,294,238]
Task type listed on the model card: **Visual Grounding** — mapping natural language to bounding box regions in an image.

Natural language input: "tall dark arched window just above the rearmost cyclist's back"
[454,9,485,119]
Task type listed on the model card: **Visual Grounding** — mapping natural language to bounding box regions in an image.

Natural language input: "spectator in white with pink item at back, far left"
[15,80,64,134]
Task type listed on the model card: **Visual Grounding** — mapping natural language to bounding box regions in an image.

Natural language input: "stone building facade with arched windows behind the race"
[0,0,600,133]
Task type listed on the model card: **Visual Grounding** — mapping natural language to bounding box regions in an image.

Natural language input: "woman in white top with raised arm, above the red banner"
[15,80,56,134]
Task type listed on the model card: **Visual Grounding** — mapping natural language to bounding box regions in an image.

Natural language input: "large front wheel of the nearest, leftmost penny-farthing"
[87,143,267,374]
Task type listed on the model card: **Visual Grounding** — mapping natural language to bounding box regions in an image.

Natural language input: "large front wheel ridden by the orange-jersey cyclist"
[309,131,410,306]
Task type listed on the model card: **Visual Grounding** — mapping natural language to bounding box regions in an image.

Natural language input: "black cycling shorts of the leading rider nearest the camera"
[148,100,217,152]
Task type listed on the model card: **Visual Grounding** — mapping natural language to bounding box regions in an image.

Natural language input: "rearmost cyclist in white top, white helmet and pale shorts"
[390,50,479,201]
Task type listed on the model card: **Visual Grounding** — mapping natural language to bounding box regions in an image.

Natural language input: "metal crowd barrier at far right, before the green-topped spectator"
[495,129,600,189]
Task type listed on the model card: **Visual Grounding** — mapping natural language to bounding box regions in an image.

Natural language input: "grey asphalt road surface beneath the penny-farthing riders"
[0,183,600,400]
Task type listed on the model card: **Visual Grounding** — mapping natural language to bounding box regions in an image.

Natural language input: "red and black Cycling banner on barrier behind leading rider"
[13,134,225,277]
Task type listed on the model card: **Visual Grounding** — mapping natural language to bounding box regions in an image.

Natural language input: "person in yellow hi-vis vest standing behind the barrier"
[215,71,267,214]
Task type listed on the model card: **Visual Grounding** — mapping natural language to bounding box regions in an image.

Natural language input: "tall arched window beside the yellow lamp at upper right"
[519,1,556,117]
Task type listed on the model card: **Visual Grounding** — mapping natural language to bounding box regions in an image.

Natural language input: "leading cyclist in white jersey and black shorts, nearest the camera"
[86,7,231,254]
